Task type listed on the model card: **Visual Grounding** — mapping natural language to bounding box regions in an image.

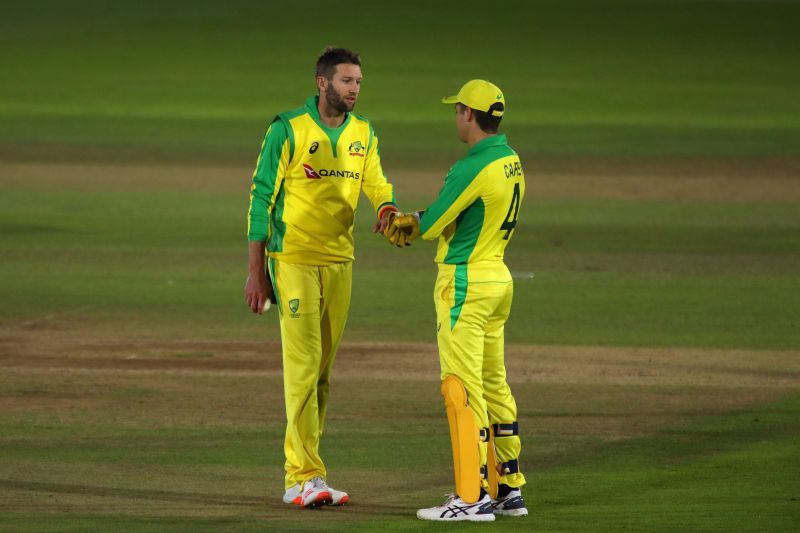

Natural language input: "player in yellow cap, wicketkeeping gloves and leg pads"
[385,80,528,521]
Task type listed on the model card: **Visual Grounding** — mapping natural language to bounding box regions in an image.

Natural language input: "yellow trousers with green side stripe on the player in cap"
[433,261,525,488]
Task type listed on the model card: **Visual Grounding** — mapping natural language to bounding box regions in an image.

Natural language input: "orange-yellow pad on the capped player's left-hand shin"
[442,376,481,503]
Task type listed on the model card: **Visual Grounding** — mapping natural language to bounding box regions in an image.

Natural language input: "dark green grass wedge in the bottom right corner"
[537,397,800,531]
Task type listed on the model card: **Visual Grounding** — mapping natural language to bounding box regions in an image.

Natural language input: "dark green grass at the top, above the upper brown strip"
[0,0,800,155]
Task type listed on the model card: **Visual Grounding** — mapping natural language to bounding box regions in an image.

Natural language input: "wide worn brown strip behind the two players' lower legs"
[0,325,800,432]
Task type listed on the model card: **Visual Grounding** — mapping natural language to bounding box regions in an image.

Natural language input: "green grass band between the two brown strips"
[0,183,800,349]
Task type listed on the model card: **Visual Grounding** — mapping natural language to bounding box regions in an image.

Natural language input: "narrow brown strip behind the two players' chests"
[0,156,800,202]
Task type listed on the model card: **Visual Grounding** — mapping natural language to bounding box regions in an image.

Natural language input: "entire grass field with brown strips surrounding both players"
[0,0,800,531]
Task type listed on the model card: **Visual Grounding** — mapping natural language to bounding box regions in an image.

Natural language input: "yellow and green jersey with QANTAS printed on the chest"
[247,96,396,265]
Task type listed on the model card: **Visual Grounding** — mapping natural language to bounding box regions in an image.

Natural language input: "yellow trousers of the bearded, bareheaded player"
[269,259,353,488]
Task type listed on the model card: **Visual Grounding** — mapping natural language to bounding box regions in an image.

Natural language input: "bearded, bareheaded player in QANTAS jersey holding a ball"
[244,48,397,507]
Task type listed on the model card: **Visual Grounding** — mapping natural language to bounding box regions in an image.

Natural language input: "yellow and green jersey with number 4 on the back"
[420,135,525,265]
